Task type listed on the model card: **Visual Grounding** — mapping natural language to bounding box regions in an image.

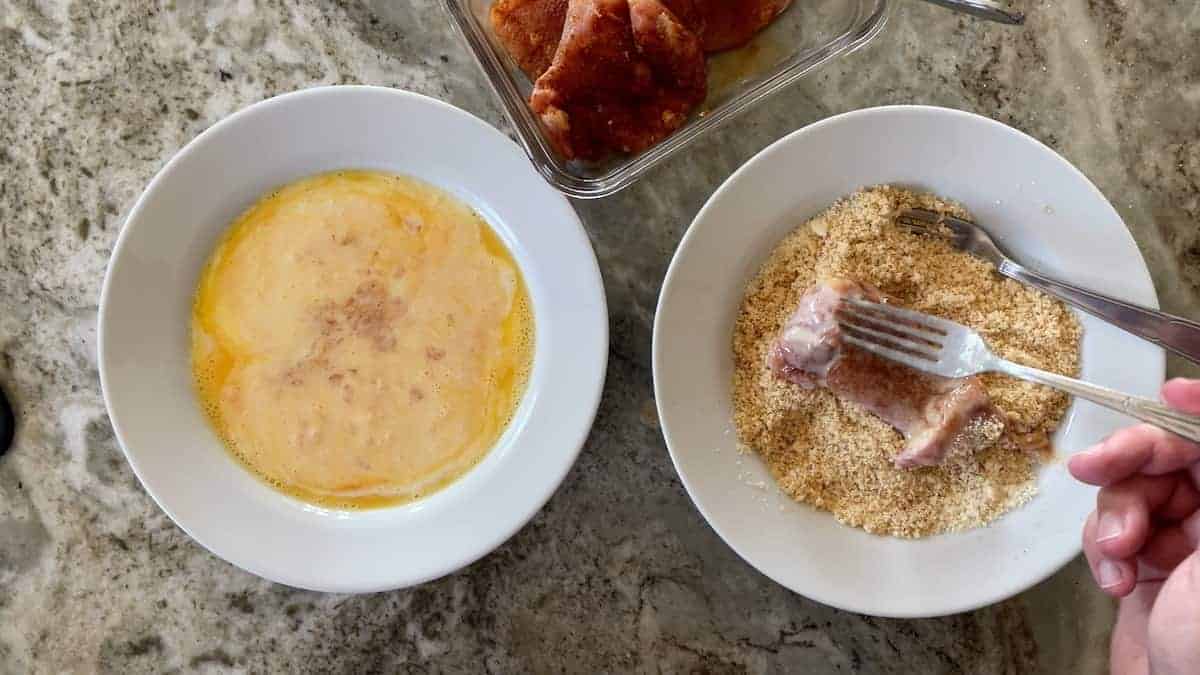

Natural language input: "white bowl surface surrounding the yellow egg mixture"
[100,86,608,592]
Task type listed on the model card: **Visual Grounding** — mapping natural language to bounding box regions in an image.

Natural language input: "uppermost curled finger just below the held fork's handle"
[1067,424,1200,486]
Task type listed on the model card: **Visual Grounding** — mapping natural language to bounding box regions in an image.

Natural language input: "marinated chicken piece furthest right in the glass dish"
[664,0,792,52]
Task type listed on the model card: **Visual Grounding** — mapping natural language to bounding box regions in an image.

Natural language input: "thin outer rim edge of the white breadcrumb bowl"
[652,104,1165,619]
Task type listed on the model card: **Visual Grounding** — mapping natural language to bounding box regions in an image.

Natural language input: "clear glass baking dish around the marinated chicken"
[444,0,888,198]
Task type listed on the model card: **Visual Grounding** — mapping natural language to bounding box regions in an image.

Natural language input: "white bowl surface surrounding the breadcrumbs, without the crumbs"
[654,106,1164,617]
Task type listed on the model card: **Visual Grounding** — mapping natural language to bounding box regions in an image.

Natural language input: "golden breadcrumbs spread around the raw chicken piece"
[733,186,1081,537]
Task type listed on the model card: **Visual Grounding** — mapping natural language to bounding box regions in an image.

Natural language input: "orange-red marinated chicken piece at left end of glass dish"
[491,0,566,79]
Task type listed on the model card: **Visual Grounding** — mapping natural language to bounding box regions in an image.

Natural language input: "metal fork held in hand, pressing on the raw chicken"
[836,298,1200,443]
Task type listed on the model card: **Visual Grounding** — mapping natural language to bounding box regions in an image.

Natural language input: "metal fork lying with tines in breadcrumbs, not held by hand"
[896,209,1200,363]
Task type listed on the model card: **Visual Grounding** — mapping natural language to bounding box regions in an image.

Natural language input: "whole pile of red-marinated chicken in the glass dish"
[491,0,791,160]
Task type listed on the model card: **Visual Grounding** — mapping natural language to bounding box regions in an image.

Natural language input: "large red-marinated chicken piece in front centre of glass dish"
[529,0,707,160]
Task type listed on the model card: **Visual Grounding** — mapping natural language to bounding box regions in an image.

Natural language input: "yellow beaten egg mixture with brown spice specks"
[192,172,534,508]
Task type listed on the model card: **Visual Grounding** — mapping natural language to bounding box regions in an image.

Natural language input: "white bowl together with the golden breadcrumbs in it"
[654,106,1163,616]
